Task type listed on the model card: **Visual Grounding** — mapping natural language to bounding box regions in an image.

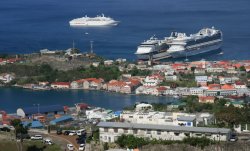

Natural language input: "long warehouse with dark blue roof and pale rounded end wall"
[17,105,64,117]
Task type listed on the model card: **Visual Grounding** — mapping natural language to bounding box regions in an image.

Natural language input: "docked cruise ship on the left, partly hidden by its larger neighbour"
[135,36,173,60]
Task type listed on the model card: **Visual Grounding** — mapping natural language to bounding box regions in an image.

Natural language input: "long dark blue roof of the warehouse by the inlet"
[23,105,64,114]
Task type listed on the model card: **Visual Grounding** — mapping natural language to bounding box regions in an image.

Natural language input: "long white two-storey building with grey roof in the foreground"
[97,122,231,142]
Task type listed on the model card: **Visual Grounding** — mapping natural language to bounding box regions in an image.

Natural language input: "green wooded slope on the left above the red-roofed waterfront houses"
[0,64,121,84]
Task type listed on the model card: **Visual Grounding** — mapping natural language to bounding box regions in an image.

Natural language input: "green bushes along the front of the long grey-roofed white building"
[116,135,215,148]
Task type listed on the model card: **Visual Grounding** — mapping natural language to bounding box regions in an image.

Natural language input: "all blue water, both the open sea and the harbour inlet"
[0,0,250,112]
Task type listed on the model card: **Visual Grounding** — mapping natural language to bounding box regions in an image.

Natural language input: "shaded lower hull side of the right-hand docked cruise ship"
[170,42,222,58]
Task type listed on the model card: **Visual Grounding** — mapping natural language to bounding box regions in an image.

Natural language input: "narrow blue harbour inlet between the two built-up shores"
[0,88,175,113]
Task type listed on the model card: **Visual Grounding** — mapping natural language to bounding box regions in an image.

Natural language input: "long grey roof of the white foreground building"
[97,122,230,134]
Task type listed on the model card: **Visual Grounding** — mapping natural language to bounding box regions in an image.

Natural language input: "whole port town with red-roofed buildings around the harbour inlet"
[0,48,250,150]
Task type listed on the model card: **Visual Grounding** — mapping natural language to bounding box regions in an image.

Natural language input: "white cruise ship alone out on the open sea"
[69,14,119,26]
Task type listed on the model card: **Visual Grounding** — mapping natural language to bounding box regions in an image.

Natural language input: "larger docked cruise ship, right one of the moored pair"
[168,27,223,58]
